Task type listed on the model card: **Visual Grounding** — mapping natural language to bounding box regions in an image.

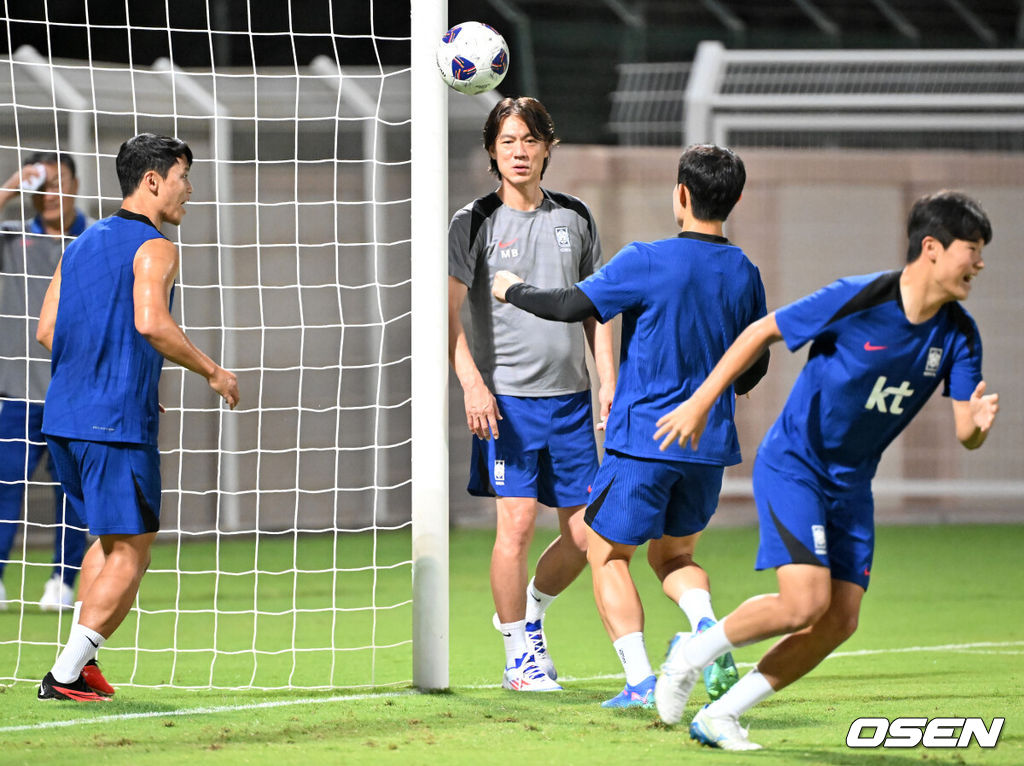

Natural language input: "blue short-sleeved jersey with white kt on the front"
[758,271,981,490]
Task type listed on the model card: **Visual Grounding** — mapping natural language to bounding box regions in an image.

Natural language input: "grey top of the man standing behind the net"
[0,213,94,403]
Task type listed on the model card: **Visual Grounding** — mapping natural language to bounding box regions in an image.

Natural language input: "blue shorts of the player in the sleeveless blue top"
[46,436,160,535]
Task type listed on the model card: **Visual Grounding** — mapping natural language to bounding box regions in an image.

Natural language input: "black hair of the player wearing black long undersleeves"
[676,143,746,221]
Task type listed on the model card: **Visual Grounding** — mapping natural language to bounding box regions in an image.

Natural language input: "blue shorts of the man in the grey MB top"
[466,391,597,508]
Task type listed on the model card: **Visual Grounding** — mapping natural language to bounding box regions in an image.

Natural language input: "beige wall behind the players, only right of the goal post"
[451,146,1024,521]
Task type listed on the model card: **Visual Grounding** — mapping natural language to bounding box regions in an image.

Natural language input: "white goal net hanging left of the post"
[0,0,446,689]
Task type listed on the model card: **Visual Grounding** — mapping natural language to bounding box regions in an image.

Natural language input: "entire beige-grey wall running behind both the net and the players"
[3,142,1024,539]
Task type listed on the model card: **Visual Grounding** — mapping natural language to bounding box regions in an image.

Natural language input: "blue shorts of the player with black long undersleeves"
[584,451,725,545]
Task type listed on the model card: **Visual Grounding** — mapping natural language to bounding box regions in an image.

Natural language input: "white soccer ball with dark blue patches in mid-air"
[437,22,509,95]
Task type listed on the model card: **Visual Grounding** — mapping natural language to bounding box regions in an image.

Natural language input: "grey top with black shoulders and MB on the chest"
[449,189,601,396]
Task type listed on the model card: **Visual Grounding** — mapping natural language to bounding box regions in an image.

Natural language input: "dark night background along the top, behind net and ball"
[0,0,1024,143]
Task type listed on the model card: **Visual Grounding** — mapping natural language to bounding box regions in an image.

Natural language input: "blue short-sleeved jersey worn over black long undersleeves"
[579,231,766,466]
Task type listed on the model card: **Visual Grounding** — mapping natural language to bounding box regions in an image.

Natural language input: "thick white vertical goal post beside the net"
[410,0,450,689]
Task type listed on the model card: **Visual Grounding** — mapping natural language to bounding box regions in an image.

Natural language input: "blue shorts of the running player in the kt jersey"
[754,460,874,590]
